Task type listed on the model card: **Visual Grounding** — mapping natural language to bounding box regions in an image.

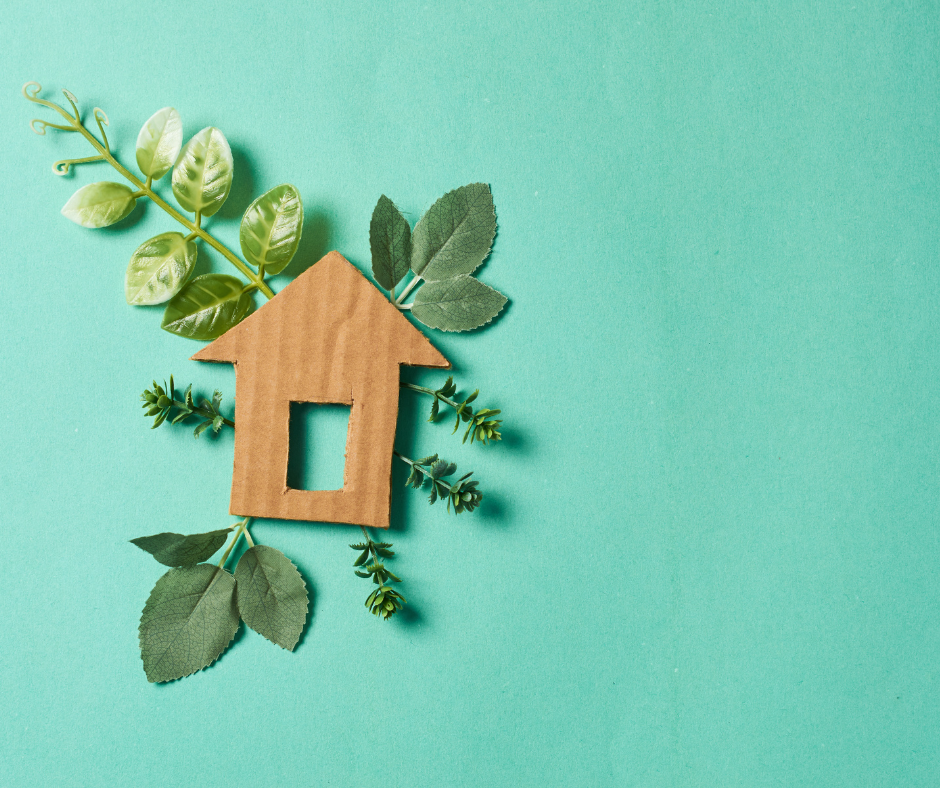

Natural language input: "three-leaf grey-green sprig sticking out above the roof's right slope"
[369,183,506,331]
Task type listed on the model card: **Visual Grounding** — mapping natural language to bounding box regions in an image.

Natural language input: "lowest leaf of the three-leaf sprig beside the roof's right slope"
[411,276,506,331]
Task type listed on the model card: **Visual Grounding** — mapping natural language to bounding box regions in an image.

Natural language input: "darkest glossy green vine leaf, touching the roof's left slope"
[161,274,254,340]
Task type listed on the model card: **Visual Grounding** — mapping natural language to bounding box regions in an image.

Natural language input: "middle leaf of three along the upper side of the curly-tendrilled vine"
[173,126,234,216]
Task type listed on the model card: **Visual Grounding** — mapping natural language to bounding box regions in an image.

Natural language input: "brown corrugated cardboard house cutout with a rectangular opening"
[193,252,450,528]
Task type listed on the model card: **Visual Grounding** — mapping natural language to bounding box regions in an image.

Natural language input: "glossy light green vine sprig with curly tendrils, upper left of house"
[23,82,303,341]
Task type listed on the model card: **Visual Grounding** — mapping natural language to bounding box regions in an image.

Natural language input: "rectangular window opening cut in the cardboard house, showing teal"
[287,402,351,490]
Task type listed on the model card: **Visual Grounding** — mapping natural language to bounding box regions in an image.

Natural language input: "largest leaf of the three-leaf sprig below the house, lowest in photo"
[139,564,238,681]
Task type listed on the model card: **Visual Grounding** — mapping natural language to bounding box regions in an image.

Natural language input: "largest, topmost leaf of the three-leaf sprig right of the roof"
[411,183,496,282]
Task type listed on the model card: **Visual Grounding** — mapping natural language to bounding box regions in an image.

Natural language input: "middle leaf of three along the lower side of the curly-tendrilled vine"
[124,233,196,306]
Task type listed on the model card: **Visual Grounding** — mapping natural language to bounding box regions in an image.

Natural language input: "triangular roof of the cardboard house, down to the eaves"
[192,252,450,368]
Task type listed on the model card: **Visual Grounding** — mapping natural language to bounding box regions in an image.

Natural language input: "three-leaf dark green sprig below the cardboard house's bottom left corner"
[131,517,309,682]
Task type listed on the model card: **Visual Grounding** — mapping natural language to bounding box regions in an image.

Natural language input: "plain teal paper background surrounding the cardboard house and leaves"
[0,0,940,788]
